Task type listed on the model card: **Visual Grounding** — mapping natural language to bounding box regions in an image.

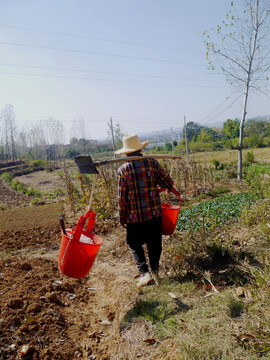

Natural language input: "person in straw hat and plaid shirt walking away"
[115,135,176,288]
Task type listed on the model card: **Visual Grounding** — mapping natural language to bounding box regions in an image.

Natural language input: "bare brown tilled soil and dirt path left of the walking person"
[0,186,170,360]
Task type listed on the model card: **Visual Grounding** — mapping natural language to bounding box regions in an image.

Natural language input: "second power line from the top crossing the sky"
[0,41,206,67]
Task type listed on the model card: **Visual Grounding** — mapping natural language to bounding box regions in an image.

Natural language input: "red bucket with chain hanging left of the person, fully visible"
[58,211,103,279]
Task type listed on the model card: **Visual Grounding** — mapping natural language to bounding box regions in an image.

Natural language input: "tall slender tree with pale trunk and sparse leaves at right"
[204,0,270,180]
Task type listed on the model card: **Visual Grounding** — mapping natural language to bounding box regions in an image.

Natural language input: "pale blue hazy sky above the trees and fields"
[0,0,270,142]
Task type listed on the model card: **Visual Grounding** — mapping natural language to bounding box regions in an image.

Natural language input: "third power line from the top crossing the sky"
[0,63,224,83]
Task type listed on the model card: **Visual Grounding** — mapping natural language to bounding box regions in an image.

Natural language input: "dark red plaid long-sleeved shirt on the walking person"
[117,158,173,225]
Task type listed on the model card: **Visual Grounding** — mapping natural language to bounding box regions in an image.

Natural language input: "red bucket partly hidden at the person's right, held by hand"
[160,189,181,235]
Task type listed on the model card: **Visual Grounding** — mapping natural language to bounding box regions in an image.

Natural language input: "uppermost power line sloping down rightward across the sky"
[0,24,204,54]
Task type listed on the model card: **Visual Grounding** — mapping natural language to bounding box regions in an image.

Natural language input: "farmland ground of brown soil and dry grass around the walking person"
[0,153,270,360]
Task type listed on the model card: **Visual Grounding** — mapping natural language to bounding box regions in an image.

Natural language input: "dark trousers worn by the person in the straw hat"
[126,217,162,274]
